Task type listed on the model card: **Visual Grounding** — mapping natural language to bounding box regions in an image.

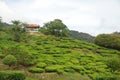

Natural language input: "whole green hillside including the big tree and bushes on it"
[0,19,120,80]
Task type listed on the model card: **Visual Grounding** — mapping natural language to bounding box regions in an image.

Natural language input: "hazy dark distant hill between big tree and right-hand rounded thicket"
[70,30,95,42]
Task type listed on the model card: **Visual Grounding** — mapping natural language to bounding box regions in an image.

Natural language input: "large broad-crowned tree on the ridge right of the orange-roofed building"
[40,19,69,36]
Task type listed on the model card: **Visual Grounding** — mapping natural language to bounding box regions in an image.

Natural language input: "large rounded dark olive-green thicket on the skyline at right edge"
[94,34,120,50]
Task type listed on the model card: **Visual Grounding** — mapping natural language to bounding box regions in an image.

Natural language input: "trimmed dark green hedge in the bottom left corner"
[0,71,26,80]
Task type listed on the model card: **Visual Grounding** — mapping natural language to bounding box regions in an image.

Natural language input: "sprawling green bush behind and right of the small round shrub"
[5,45,36,66]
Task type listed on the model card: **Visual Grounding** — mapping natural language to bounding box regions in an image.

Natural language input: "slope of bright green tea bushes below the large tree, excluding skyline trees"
[0,35,120,80]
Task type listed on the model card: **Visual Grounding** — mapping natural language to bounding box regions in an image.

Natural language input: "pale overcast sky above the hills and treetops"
[0,0,120,36]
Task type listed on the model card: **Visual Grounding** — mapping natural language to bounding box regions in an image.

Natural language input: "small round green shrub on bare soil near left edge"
[3,55,17,66]
